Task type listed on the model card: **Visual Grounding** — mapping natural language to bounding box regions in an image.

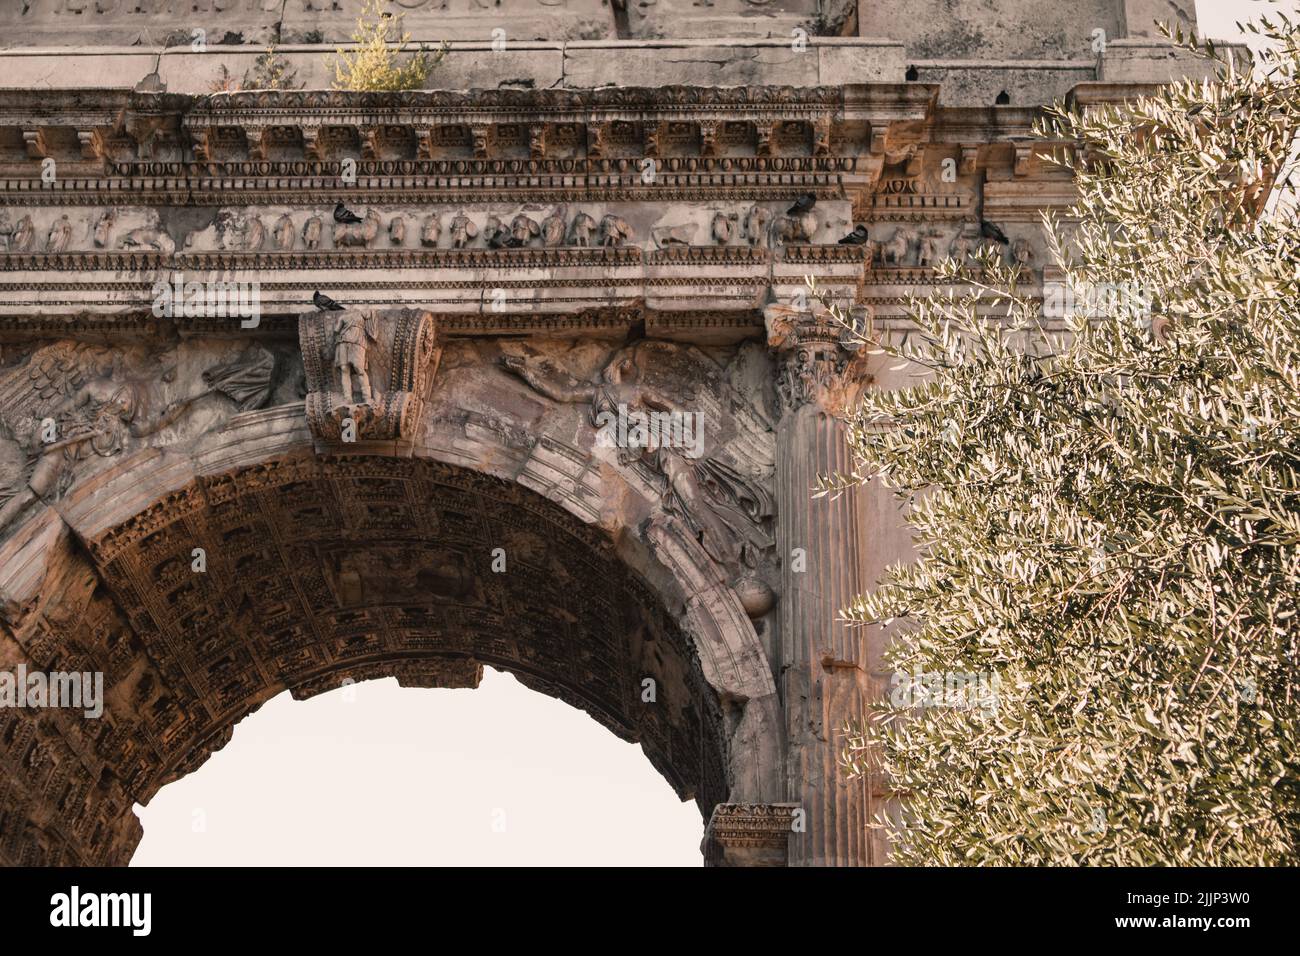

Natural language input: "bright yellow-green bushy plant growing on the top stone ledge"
[332,0,447,90]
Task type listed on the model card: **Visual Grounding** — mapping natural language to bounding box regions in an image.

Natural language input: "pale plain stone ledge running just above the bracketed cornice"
[0,38,1245,99]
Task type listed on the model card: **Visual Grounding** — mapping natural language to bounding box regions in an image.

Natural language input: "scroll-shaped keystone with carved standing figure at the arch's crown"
[298,308,442,444]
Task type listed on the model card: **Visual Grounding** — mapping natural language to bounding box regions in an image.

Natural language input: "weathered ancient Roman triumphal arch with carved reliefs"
[0,0,1227,865]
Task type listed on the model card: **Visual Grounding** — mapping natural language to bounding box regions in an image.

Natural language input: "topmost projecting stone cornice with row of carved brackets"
[0,83,937,178]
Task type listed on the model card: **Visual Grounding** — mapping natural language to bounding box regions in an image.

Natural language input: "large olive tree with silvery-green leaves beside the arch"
[823,17,1300,865]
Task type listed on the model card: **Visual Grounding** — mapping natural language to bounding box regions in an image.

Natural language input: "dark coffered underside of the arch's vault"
[0,455,731,864]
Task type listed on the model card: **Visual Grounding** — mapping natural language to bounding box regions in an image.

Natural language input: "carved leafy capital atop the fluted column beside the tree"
[763,304,870,416]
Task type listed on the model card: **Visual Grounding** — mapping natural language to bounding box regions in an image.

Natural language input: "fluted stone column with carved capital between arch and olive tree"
[767,307,878,866]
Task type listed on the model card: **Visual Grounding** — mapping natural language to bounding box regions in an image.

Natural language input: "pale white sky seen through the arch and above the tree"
[131,0,1295,866]
